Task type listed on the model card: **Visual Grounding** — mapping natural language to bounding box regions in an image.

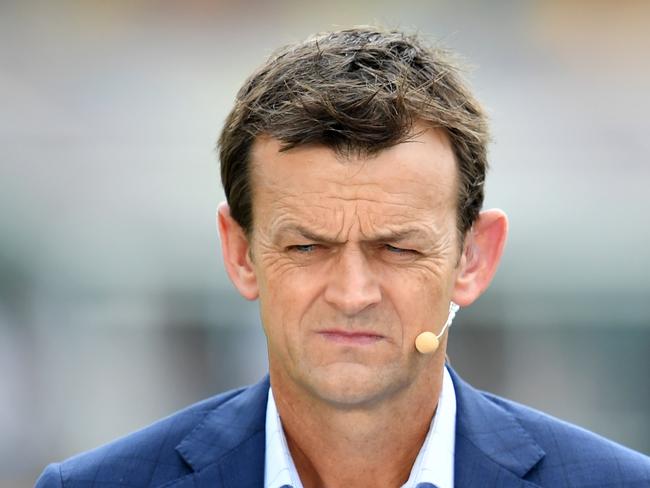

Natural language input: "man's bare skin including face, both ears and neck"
[218,125,507,488]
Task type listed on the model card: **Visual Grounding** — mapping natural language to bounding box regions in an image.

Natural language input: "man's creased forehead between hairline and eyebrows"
[251,128,457,239]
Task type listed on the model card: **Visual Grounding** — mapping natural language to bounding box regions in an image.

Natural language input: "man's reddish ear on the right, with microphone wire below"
[452,209,508,307]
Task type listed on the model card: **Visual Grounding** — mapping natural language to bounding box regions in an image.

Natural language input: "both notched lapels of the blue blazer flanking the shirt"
[166,366,545,488]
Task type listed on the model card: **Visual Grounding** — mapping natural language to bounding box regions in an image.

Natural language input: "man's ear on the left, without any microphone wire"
[217,202,258,300]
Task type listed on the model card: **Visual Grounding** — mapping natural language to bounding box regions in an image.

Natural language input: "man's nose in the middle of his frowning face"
[325,249,381,316]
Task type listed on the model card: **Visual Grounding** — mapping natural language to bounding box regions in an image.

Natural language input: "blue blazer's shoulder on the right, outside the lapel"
[481,392,650,486]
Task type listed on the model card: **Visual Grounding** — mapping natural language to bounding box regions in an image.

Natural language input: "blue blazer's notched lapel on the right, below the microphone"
[448,367,545,488]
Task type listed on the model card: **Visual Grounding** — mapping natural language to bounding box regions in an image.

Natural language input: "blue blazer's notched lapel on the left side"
[167,376,269,488]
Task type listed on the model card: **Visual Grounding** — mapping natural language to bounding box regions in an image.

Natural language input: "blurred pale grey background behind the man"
[0,0,650,487]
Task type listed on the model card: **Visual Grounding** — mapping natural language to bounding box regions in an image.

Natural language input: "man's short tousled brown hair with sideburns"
[218,27,489,242]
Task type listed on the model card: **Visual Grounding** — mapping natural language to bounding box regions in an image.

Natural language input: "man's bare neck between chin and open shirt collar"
[271,356,444,488]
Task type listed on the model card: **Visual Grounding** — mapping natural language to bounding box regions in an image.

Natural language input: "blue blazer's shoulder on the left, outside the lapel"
[36,388,246,488]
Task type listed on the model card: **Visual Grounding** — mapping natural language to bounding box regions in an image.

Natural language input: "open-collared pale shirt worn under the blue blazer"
[264,368,456,488]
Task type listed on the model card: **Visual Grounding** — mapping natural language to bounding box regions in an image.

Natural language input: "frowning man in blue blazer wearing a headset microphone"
[38,28,650,488]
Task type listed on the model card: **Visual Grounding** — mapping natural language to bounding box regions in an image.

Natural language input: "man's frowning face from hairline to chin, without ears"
[246,129,459,406]
